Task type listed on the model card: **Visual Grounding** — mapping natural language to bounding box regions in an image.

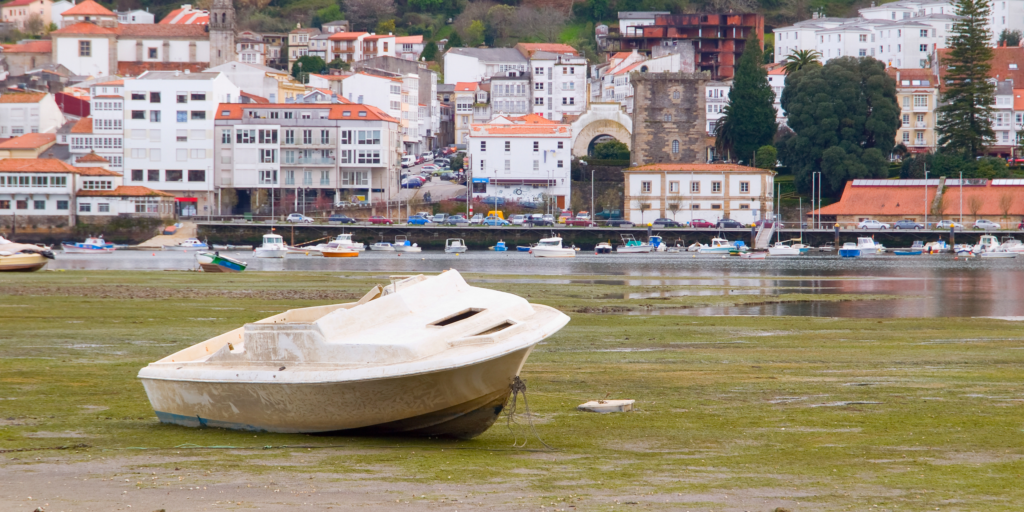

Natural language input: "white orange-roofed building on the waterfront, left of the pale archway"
[466,115,572,208]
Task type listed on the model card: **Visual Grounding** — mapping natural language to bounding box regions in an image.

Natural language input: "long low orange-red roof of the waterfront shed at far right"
[815,180,1024,217]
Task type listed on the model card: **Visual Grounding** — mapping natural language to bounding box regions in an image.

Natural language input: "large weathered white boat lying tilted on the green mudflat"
[138,270,569,438]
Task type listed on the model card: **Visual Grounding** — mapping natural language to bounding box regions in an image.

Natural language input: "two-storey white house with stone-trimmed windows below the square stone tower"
[623,164,775,225]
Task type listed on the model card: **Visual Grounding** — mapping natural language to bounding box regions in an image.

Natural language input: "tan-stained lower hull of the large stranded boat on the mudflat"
[139,340,540,438]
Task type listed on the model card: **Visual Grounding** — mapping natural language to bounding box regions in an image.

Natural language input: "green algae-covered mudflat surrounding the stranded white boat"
[0,271,1024,510]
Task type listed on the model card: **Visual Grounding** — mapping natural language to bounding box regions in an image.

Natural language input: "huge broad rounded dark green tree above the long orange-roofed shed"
[780,57,899,196]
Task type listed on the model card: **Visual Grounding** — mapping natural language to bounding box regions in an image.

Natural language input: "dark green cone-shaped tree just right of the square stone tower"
[720,31,778,165]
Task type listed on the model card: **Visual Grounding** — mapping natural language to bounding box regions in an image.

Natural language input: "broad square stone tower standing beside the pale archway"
[630,72,713,165]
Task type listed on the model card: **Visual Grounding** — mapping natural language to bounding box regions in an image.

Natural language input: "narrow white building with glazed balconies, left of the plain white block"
[68,80,125,169]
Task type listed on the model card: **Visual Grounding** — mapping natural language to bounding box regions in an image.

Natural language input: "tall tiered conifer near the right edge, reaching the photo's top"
[936,0,995,157]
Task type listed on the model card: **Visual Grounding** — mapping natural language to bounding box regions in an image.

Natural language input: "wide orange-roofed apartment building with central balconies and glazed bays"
[215,103,401,208]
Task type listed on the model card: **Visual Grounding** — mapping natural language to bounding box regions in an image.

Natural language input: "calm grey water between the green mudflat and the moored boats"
[47,251,1024,317]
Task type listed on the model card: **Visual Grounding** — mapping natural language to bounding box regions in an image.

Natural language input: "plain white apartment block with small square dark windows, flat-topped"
[124,72,240,214]
